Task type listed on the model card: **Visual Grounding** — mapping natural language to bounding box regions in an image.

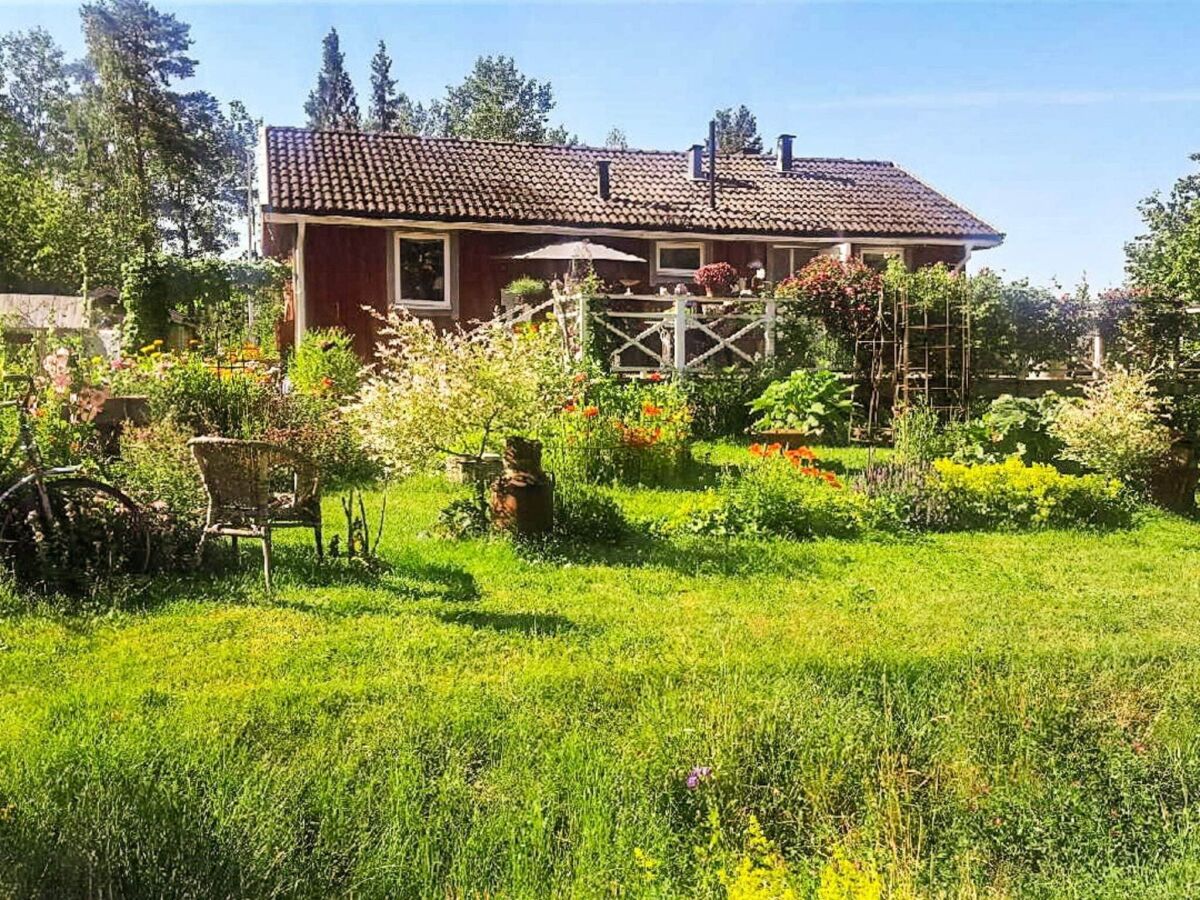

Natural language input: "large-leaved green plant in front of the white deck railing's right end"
[750,368,854,439]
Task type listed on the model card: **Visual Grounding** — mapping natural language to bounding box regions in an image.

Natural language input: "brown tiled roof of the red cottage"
[266,127,1002,242]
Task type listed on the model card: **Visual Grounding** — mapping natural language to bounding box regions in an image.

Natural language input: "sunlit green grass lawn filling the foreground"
[0,448,1200,898]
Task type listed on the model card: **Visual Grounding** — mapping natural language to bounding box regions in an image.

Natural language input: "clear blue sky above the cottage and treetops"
[0,0,1200,288]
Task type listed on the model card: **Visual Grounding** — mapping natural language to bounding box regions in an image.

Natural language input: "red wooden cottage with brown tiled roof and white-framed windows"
[263,127,1003,355]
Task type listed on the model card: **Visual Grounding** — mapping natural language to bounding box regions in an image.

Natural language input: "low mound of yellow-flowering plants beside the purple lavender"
[934,456,1133,529]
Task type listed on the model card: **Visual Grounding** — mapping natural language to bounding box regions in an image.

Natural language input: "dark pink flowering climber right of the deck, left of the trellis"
[775,256,883,343]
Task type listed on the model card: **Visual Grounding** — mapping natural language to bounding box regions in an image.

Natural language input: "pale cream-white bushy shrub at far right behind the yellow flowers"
[1050,370,1171,491]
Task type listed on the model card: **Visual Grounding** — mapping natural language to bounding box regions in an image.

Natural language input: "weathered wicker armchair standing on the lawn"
[187,438,323,590]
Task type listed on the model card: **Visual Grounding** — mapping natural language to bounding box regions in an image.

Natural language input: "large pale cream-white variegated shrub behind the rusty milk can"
[346,311,569,476]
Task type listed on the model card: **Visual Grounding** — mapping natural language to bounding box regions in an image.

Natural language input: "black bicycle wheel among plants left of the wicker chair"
[0,478,150,593]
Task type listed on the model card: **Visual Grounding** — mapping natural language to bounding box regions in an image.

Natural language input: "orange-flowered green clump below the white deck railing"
[547,372,691,484]
